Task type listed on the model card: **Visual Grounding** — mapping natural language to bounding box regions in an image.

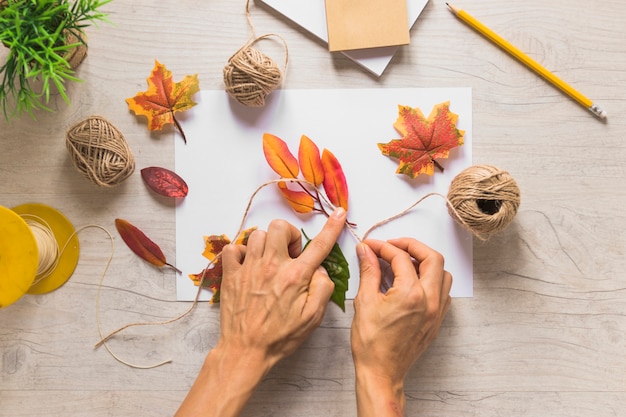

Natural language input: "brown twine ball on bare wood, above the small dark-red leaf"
[66,116,135,187]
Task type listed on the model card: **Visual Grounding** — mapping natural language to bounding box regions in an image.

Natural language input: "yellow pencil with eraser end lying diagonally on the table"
[446,3,607,120]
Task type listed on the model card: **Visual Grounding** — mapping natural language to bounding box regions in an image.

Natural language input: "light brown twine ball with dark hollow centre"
[448,165,520,240]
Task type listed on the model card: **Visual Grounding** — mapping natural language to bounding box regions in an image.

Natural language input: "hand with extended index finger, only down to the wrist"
[220,209,346,367]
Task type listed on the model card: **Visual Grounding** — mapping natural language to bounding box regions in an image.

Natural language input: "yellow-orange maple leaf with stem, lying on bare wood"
[126,60,200,143]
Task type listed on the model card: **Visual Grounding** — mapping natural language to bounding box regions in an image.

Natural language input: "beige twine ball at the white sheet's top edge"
[224,41,283,107]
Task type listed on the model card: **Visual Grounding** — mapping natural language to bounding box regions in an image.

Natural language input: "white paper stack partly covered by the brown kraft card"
[258,0,428,77]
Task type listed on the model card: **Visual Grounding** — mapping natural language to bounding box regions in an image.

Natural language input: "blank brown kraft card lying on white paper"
[325,0,409,52]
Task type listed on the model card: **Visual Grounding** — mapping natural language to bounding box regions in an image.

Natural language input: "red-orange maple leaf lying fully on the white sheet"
[378,101,465,178]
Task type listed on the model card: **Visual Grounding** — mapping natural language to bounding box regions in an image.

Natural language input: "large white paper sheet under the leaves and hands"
[175,88,473,300]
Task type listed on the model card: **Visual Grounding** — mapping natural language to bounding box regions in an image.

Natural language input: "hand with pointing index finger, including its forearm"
[176,209,346,417]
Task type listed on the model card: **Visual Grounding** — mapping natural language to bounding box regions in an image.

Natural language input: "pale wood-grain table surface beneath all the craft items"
[0,0,626,417]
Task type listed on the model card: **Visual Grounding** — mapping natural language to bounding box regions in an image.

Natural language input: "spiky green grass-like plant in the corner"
[0,0,111,120]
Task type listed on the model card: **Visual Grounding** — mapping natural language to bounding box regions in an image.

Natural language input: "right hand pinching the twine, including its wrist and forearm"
[351,238,452,417]
